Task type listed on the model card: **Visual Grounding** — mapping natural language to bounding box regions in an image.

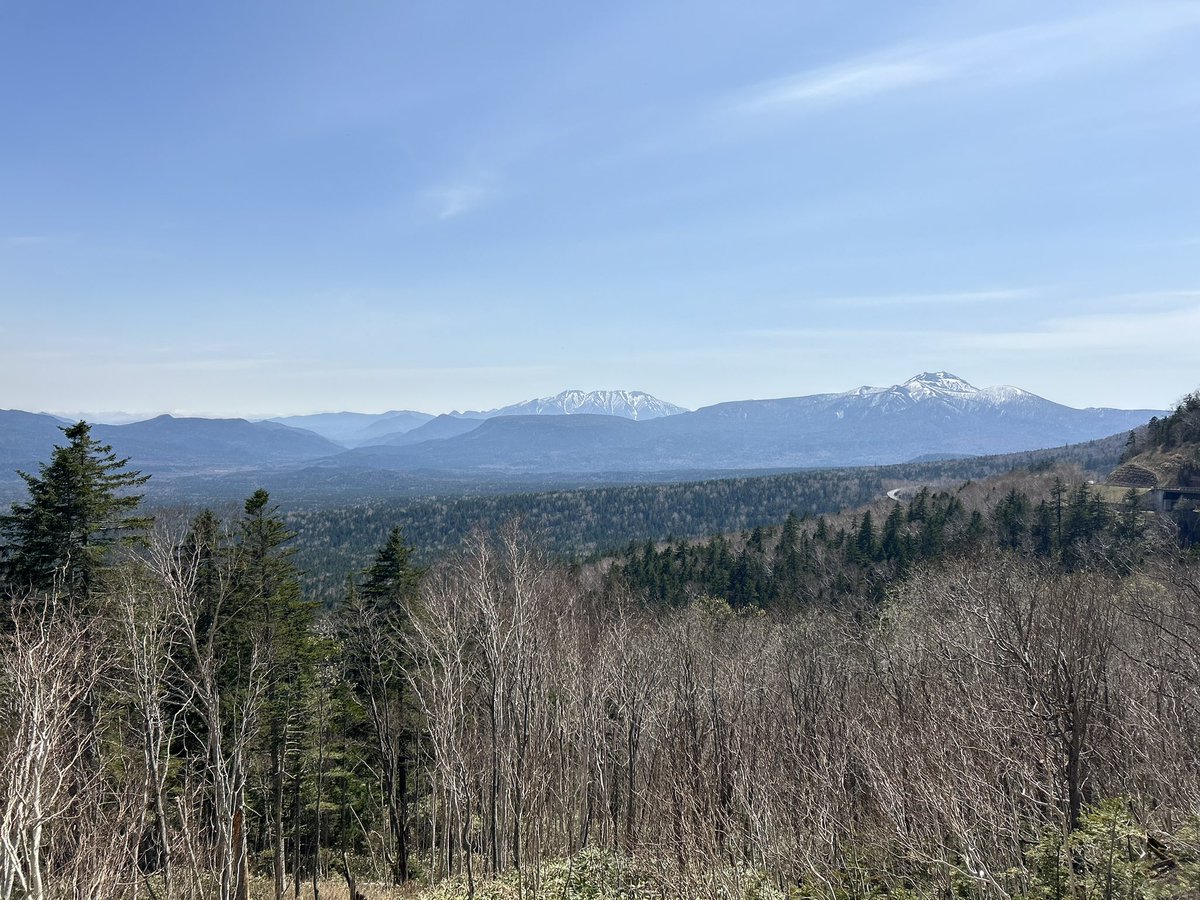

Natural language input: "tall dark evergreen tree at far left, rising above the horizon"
[0,421,150,602]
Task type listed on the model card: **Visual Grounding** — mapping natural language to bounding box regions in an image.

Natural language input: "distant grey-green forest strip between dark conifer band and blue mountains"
[274,434,1127,605]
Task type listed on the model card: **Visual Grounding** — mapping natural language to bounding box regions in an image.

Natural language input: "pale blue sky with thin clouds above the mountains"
[0,0,1200,416]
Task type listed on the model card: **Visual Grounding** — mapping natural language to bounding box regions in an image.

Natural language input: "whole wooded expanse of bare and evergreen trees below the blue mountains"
[0,398,1200,900]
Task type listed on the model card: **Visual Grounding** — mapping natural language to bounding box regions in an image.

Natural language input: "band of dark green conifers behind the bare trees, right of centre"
[606,479,1145,608]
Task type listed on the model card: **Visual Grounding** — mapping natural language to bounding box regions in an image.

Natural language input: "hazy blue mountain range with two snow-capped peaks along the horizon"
[0,372,1162,496]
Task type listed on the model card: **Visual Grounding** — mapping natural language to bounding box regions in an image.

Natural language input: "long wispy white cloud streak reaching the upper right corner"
[732,2,1200,114]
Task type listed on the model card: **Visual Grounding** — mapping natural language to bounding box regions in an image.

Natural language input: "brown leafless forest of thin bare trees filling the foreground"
[0,518,1200,899]
